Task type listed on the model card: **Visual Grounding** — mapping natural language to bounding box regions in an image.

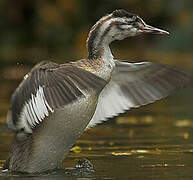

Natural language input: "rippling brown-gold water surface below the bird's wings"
[0,87,193,180]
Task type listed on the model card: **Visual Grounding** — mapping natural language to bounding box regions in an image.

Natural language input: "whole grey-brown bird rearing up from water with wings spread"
[4,10,192,173]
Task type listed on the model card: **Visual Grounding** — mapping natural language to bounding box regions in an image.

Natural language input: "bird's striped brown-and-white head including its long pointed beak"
[87,9,169,58]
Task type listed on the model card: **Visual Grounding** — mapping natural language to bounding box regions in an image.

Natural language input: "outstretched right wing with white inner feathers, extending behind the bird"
[87,61,193,127]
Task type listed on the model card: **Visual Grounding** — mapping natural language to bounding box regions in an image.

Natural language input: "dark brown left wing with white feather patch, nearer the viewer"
[8,62,106,133]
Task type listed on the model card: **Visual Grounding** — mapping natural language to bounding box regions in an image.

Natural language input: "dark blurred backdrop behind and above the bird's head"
[0,0,193,66]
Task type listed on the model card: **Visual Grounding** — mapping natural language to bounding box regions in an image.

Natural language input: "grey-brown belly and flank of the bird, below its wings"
[7,80,98,172]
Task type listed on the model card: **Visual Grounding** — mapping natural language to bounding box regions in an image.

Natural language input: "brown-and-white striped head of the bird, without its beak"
[87,10,140,44]
